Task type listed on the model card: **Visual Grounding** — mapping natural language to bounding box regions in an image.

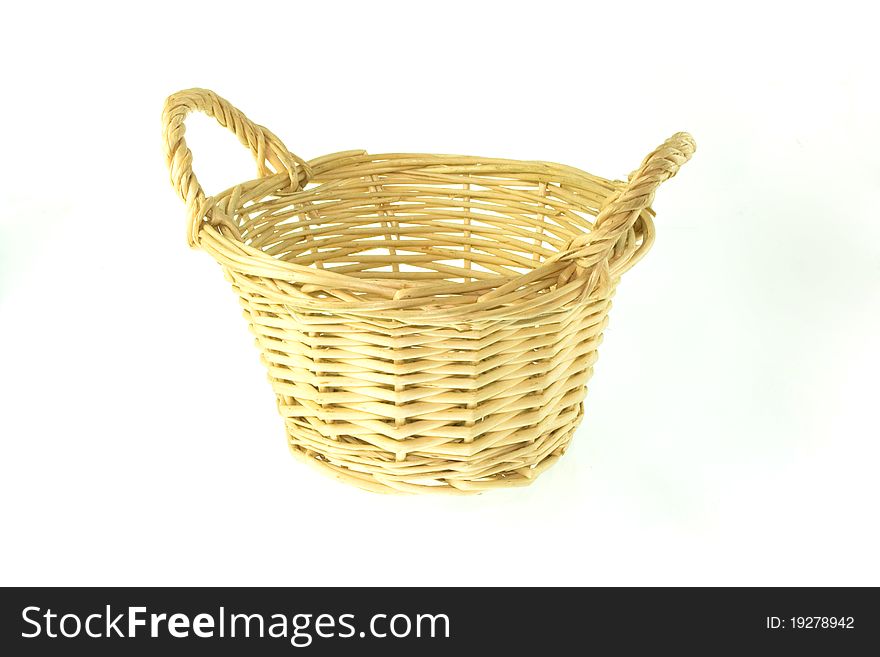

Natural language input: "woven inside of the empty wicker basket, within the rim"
[218,152,621,285]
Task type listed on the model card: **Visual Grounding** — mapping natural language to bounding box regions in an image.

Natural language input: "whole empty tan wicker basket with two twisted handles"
[163,89,695,493]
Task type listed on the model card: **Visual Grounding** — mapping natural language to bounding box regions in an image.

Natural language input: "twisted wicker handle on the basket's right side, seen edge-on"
[558,132,697,268]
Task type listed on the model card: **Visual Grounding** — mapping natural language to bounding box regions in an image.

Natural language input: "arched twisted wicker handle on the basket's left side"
[162,89,311,246]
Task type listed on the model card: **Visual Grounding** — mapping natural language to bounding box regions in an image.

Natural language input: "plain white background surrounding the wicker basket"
[0,0,880,585]
